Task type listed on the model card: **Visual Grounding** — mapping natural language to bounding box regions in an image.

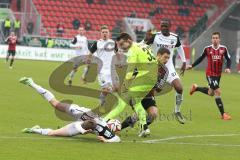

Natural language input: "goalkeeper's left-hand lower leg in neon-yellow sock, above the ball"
[104,94,126,121]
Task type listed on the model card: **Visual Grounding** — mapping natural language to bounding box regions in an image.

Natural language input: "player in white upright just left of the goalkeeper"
[88,25,124,105]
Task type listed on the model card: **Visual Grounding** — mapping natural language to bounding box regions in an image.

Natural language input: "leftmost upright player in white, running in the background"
[68,27,89,85]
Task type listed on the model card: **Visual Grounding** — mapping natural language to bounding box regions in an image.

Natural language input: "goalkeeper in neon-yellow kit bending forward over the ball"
[105,33,158,136]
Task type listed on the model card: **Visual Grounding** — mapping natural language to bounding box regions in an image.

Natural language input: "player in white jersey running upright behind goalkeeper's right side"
[147,19,186,124]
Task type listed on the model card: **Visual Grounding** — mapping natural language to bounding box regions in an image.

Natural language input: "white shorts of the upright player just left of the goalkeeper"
[98,71,119,91]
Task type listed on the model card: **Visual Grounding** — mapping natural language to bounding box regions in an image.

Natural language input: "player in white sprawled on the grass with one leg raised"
[19,77,120,142]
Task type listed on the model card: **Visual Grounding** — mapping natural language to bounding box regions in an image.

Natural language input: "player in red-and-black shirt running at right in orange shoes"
[187,32,231,120]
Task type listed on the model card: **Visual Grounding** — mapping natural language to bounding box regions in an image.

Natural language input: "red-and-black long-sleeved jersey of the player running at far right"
[192,45,231,76]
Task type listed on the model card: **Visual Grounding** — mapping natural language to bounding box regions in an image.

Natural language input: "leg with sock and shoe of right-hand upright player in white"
[172,78,185,124]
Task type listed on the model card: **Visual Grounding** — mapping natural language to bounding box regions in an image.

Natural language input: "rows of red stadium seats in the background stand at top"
[8,0,231,39]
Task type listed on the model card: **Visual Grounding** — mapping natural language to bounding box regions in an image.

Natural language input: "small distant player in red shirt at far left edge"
[5,32,17,69]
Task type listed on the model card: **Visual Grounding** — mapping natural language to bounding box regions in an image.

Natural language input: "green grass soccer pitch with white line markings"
[0,59,240,160]
